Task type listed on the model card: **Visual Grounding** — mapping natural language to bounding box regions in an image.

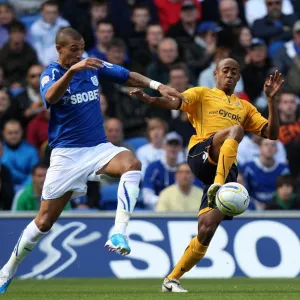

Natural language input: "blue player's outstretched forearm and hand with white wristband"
[125,72,188,103]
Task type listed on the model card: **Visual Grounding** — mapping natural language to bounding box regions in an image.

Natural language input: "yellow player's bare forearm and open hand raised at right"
[264,70,284,140]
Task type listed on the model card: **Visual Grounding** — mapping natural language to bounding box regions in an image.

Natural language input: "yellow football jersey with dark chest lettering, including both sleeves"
[180,87,268,149]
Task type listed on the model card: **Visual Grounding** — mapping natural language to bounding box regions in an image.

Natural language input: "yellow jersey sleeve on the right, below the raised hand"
[242,101,268,136]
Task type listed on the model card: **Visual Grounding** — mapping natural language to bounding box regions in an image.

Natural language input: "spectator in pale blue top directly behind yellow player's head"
[198,47,244,93]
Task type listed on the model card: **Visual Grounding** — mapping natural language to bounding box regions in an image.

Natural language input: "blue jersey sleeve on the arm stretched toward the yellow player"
[98,61,130,83]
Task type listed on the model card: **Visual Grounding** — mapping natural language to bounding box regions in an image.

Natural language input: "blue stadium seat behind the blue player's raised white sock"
[100,184,144,210]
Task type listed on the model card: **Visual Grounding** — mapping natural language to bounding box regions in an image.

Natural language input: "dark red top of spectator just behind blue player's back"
[26,109,50,154]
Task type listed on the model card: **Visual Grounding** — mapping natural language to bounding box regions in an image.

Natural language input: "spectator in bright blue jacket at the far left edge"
[2,120,39,191]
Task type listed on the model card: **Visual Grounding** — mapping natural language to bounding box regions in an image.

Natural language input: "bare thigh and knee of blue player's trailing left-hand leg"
[35,191,73,231]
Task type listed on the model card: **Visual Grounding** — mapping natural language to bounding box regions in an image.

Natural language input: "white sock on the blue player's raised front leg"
[113,171,142,234]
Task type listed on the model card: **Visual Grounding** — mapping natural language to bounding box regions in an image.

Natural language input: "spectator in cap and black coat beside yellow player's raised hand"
[242,38,271,103]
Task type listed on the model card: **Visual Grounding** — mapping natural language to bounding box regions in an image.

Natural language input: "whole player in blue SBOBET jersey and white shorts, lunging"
[0,28,186,293]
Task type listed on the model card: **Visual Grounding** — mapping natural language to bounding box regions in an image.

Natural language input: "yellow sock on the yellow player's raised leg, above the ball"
[214,139,239,184]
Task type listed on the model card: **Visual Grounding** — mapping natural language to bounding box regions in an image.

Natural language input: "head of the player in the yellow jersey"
[214,59,240,92]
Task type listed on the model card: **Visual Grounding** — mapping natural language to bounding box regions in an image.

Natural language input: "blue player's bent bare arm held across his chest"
[45,58,103,104]
